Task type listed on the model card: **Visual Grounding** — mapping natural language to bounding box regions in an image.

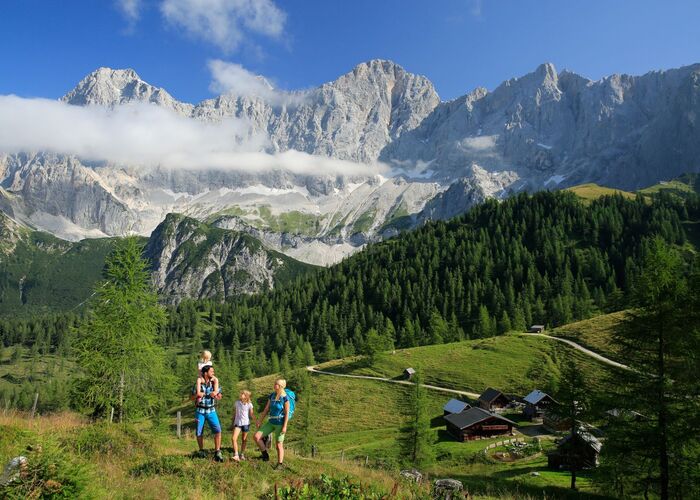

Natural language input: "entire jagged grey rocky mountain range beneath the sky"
[0,60,700,295]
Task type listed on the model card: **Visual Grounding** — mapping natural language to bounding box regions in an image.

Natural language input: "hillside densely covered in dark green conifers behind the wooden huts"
[171,192,700,362]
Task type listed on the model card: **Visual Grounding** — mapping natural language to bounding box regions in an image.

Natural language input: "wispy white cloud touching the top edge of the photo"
[160,0,287,53]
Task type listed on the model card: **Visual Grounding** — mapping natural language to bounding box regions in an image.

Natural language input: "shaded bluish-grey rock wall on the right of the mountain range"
[380,64,700,189]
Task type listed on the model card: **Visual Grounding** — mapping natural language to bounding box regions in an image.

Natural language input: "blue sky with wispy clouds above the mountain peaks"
[0,0,700,102]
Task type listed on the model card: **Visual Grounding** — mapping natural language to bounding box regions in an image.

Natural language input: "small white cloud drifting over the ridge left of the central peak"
[207,59,305,105]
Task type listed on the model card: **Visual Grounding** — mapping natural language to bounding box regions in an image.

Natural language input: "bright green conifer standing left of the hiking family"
[75,237,173,422]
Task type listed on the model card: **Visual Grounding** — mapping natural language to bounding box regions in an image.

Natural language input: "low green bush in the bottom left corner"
[0,441,89,499]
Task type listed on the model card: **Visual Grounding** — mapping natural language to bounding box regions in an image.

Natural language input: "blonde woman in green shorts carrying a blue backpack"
[255,378,296,470]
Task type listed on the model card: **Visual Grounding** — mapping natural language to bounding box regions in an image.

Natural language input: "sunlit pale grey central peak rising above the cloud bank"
[192,60,440,162]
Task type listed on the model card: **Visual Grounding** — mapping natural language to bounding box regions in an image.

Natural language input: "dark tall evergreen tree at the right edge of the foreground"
[602,238,700,499]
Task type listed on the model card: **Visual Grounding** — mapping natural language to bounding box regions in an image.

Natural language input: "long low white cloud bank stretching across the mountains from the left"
[0,95,388,176]
